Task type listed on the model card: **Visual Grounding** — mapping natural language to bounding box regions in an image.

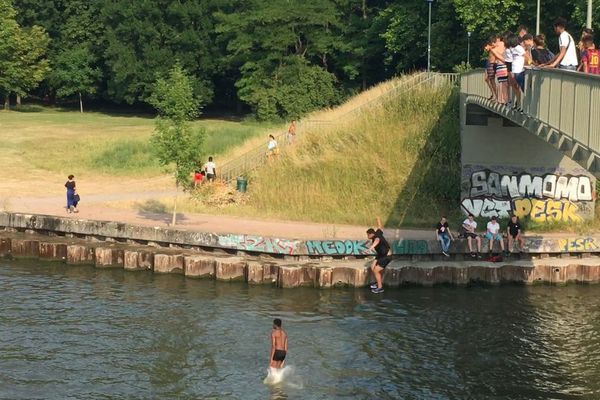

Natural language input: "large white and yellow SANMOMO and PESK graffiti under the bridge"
[461,170,596,222]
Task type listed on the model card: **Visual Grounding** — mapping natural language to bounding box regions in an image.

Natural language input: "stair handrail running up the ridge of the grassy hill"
[219,72,460,184]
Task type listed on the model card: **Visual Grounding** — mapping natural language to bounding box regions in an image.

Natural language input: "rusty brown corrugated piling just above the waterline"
[0,232,600,289]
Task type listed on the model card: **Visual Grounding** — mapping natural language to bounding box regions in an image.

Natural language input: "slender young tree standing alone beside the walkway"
[149,62,204,225]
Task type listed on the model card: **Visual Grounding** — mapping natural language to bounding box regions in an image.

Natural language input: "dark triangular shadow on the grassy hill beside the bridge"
[385,90,461,229]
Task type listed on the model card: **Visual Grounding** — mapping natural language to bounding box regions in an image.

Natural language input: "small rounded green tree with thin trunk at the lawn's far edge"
[48,45,102,112]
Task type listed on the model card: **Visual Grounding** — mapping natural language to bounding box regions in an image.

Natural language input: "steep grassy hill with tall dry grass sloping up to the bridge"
[218,76,460,226]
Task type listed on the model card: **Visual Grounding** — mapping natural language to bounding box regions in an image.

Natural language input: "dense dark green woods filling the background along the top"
[5,0,600,119]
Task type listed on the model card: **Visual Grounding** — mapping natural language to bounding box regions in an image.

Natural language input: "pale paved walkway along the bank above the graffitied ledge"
[2,191,576,240]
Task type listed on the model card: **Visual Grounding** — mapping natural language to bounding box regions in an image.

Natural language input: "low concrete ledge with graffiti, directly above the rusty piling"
[0,212,600,258]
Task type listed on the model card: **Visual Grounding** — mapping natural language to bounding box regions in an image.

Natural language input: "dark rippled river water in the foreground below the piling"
[0,261,600,399]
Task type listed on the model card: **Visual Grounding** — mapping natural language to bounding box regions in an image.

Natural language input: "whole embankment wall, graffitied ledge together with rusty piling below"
[0,213,600,288]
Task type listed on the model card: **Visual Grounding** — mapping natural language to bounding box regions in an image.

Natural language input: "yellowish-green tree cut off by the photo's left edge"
[0,0,50,109]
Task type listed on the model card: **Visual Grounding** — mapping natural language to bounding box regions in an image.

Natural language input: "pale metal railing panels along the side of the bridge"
[461,68,600,153]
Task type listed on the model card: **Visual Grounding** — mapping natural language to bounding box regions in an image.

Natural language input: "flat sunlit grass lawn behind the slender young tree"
[0,106,269,176]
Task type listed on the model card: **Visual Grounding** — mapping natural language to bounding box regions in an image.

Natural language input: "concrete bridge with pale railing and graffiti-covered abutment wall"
[460,69,600,223]
